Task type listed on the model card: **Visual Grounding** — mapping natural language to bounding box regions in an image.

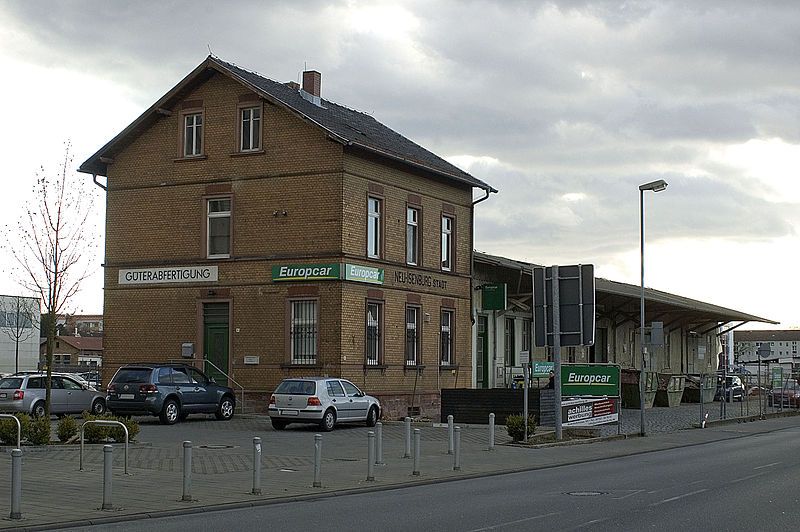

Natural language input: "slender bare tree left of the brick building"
[7,142,98,416]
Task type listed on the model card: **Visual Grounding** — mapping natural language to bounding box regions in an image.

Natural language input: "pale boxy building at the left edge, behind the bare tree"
[0,295,40,373]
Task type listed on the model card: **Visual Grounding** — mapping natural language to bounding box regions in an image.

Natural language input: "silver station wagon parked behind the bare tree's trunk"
[0,373,106,417]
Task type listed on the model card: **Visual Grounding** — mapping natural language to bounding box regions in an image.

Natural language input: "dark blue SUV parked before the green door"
[106,363,236,425]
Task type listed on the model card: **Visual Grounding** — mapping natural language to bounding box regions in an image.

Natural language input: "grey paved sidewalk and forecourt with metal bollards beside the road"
[0,410,800,530]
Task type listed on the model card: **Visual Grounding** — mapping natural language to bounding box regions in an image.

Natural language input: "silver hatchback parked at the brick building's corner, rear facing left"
[269,377,381,432]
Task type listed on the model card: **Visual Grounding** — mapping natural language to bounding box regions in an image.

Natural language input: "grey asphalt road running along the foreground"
[59,422,800,532]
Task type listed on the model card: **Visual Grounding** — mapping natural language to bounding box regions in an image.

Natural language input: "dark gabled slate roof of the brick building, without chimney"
[78,56,497,192]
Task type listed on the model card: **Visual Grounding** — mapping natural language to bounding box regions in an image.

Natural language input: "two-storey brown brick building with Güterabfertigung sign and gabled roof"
[79,56,496,417]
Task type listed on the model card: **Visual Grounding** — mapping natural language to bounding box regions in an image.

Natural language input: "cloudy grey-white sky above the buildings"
[0,0,800,328]
